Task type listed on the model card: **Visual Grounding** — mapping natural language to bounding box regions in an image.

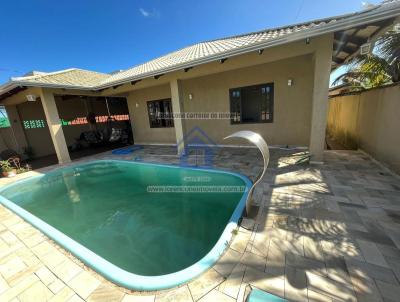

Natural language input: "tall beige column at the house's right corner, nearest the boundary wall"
[310,34,333,163]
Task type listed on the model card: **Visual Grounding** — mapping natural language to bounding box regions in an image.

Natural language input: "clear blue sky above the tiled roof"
[0,0,379,83]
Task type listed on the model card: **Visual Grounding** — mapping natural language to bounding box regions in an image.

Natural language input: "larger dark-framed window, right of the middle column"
[229,83,274,124]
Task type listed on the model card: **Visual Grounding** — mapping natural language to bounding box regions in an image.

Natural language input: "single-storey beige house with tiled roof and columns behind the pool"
[0,0,400,163]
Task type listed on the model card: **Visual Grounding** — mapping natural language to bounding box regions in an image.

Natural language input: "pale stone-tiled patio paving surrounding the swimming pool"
[0,147,400,302]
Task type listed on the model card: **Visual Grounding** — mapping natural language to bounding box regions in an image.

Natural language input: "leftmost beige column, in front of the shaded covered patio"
[40,89,71,164]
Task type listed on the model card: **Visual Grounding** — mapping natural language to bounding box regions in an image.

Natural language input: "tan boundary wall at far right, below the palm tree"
[328,85,400,173]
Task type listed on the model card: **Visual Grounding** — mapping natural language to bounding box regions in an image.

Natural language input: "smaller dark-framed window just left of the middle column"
[147,99,174,128]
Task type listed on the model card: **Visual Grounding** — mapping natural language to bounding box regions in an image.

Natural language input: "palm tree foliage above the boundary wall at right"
[333,29,400,90]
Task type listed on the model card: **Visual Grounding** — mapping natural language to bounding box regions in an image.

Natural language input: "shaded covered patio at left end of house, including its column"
[0,89,133,169]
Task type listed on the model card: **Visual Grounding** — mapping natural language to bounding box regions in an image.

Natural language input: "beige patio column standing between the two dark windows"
[170,79,186,155]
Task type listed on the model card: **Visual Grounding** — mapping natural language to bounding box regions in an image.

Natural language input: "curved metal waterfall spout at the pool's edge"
[224,131,269,215]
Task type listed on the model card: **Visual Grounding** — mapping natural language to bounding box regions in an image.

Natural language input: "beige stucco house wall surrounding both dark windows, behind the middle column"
[128,54,313,146]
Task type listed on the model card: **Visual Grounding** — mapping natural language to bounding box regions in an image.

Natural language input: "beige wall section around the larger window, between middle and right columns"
[182,56,313,146]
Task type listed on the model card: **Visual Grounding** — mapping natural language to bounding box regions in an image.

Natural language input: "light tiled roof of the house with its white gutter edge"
[0,0,400,95]
